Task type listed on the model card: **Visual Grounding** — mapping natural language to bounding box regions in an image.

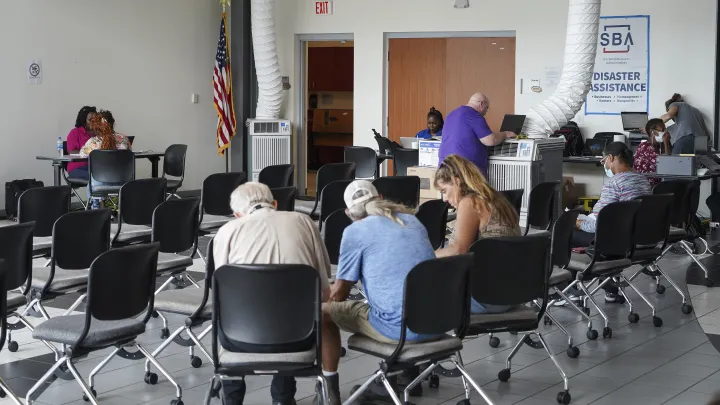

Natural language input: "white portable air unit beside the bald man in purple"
[488,138,565,225]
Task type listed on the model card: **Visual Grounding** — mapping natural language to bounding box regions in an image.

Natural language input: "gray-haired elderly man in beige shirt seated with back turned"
[213,183,330,405]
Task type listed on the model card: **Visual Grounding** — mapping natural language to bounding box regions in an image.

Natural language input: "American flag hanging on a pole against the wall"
[213,13,235,155]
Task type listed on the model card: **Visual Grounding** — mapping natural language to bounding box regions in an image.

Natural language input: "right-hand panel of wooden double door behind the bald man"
[443,38,515,131]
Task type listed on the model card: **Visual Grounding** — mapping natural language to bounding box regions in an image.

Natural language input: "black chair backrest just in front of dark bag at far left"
[18,186,72,236]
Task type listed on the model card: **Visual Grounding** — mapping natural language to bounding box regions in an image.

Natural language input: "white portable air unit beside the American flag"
[248,119,292,181]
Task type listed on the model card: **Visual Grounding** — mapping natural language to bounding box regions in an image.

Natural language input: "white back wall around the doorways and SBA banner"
[276,0,717,147]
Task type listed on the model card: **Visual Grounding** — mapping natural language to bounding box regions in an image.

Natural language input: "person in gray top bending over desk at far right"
[660,93,710,155]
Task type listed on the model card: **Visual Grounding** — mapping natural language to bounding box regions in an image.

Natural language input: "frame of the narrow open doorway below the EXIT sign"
[293,33,355,195]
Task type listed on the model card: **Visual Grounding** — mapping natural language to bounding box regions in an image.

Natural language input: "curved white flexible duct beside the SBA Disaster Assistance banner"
[523,0,602,138]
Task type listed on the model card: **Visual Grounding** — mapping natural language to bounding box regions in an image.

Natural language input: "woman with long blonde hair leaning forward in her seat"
[435,155,520,314]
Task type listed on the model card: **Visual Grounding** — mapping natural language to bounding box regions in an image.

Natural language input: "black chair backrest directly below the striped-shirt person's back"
[635,194,675,247]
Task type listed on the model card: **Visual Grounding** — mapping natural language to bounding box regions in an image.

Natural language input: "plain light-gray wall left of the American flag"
[0,0,225,201]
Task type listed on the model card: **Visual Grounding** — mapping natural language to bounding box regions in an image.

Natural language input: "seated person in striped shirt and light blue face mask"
[573,142,652,303]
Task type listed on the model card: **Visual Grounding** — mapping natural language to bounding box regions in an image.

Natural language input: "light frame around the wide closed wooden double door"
[382,30,517,145]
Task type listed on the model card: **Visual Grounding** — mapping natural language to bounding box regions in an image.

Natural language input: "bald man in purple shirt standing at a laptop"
[438,93,516,177]
